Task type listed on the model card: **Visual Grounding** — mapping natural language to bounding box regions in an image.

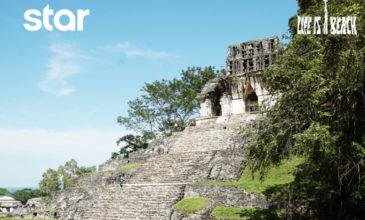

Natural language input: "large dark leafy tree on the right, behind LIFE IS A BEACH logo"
[246,0,365,218]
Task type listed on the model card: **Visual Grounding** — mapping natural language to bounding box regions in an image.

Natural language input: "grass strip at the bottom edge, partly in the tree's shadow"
[212,206,281,220]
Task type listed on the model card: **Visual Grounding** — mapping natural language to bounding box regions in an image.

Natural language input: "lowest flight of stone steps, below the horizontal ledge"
[81,185,184,220]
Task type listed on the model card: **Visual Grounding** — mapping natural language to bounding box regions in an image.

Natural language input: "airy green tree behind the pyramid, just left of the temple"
[118,67,216,136]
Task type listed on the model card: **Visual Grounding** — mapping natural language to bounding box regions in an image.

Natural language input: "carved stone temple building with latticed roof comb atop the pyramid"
[198,37,279,119]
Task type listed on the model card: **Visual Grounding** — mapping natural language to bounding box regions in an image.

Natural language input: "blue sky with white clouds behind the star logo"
[0,0,297,187]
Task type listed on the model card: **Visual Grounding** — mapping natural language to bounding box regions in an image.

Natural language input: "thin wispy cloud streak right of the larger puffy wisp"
[102,42,180,58]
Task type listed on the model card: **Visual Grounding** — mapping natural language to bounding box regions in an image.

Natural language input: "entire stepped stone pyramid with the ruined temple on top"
[13,37,278,220]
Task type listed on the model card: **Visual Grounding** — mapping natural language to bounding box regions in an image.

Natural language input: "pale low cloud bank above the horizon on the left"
[0,129,126,187]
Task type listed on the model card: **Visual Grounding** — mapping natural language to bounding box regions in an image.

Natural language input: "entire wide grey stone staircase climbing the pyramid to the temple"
[52,114,249,220]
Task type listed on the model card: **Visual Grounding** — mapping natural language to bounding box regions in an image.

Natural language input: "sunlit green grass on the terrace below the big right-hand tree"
[192,157,304,194]
